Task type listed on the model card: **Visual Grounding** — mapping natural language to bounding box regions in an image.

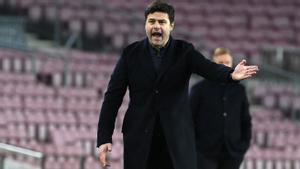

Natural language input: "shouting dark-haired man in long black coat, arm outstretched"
[97,2,258,169]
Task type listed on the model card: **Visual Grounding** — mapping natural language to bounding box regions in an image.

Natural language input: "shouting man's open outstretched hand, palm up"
[231,60,258,81]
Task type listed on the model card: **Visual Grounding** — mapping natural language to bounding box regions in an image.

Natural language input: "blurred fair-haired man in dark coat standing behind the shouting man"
[190,48,251,169]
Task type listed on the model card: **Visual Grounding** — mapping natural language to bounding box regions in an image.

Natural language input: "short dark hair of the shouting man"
[145,0,175,23]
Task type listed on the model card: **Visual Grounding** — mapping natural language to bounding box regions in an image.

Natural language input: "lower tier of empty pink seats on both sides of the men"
[0,46,300,169]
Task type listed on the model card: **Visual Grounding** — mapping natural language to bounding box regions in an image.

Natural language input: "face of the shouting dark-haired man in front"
[145,12,174,48]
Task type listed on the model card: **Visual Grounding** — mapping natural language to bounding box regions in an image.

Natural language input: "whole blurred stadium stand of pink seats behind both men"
[0,0,300,169]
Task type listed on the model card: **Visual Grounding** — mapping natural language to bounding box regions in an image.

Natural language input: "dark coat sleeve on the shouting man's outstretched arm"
[188,45,234,82]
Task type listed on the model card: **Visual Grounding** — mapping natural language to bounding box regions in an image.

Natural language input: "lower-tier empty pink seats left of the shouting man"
[0,49,118,169]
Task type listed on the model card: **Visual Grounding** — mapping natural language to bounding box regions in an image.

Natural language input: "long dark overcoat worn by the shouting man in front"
[97,37,232,169]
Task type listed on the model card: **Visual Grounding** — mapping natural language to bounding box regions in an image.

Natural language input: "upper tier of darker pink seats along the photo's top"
[0,0,300,58]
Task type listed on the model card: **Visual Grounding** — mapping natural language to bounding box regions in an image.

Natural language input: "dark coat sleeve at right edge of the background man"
[241,87,252,149]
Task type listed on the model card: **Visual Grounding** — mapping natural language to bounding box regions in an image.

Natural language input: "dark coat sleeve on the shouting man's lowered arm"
[97,52,128,147]
